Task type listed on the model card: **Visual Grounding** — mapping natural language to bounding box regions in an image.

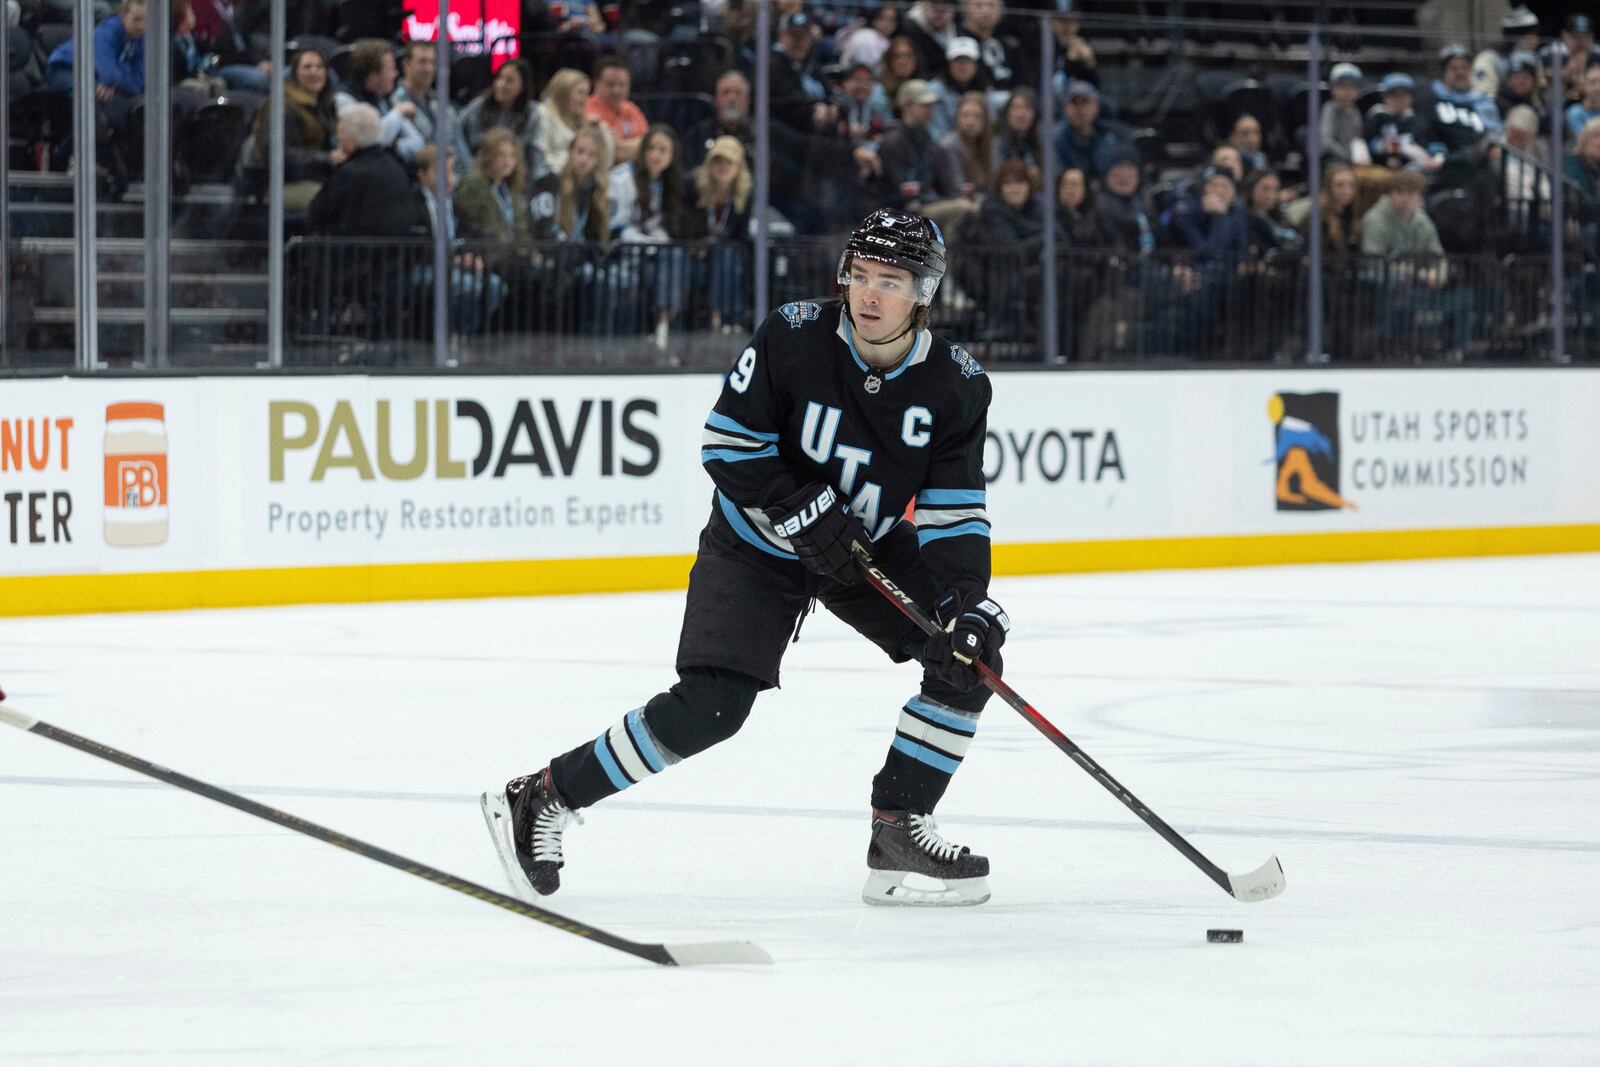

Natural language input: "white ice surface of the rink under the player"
[0,555,1600,1067]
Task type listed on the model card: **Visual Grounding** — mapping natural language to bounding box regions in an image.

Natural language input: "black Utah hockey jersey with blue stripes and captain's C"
[701,301,990,590]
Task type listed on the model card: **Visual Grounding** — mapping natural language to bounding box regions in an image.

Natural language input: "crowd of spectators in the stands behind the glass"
[9,0,1600,358]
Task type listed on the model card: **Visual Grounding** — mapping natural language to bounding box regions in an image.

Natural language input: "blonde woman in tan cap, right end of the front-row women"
[688,138,752,333]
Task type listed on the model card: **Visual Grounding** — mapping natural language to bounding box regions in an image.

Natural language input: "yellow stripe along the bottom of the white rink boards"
[0,525,1600,616]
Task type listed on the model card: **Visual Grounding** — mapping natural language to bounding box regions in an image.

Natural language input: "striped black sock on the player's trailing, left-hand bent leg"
[550,667,760,808]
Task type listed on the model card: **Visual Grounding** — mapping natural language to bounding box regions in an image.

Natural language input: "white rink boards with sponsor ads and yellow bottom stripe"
[0,370,1600,614]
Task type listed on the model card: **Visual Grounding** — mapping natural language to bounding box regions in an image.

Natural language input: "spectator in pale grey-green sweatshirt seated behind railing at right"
[1362,171,1472,354]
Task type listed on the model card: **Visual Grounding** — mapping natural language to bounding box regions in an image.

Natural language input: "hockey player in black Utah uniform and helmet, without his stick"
[483,211,1010,905]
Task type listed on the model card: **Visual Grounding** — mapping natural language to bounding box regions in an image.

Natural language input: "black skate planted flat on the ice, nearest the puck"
[861,808,989,907]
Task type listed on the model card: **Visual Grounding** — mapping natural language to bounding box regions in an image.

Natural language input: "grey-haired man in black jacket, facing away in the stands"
[306,104,427,237]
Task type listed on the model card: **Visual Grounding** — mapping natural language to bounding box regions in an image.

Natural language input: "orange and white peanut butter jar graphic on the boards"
[106,402,166,545]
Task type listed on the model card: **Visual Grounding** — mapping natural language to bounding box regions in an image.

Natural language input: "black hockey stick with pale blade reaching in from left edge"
[0,693,773,966]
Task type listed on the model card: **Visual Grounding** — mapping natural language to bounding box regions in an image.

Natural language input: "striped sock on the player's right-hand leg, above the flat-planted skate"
[872,686,989,813]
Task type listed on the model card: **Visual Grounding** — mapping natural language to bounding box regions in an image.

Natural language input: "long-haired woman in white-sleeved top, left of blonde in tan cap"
[606,123,690,349]
